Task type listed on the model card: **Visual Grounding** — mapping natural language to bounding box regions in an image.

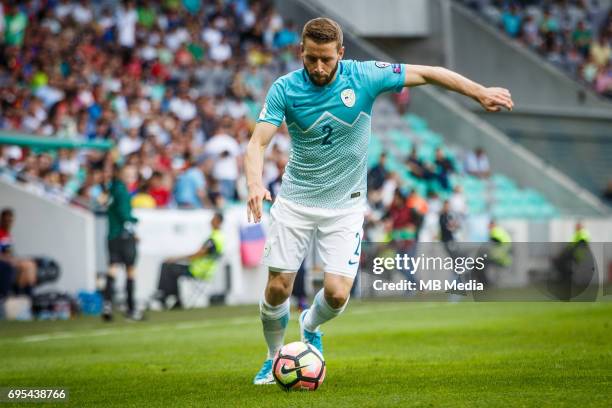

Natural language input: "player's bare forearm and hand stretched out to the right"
[404,65,514,112]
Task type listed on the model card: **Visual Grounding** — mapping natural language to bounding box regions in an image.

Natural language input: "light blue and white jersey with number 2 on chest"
[258,60,405,209]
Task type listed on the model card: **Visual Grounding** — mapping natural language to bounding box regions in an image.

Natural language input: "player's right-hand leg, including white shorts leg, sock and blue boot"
[299,212,363,353]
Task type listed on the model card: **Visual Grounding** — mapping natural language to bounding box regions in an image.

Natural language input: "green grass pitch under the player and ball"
[0,301,612,408]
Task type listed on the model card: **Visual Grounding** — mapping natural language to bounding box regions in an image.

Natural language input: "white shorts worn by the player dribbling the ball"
[263,197,364,278]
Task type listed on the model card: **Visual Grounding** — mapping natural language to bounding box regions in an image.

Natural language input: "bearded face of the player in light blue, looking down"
[302,38,344,86]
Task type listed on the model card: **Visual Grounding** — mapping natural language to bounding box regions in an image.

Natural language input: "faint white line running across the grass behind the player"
[5,302,438,343]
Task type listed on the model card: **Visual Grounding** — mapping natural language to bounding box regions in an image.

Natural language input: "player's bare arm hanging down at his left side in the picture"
[244,122,278,222]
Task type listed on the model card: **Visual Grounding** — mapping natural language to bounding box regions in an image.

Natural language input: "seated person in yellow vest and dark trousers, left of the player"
[154,213,225,309]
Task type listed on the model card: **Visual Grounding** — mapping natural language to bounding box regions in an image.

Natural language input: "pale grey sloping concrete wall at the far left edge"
[0,180,96,293]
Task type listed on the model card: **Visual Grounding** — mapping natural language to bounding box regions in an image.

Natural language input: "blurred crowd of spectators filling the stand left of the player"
[0,0,301,209]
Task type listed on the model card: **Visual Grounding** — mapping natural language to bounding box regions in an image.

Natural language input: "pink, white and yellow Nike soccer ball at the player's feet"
[272,341,325,391]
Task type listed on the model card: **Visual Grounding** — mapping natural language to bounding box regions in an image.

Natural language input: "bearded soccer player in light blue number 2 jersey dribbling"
[245,18,513,384]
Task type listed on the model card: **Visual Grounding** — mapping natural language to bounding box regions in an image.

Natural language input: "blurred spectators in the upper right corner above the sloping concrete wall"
[462,0,612,98]
